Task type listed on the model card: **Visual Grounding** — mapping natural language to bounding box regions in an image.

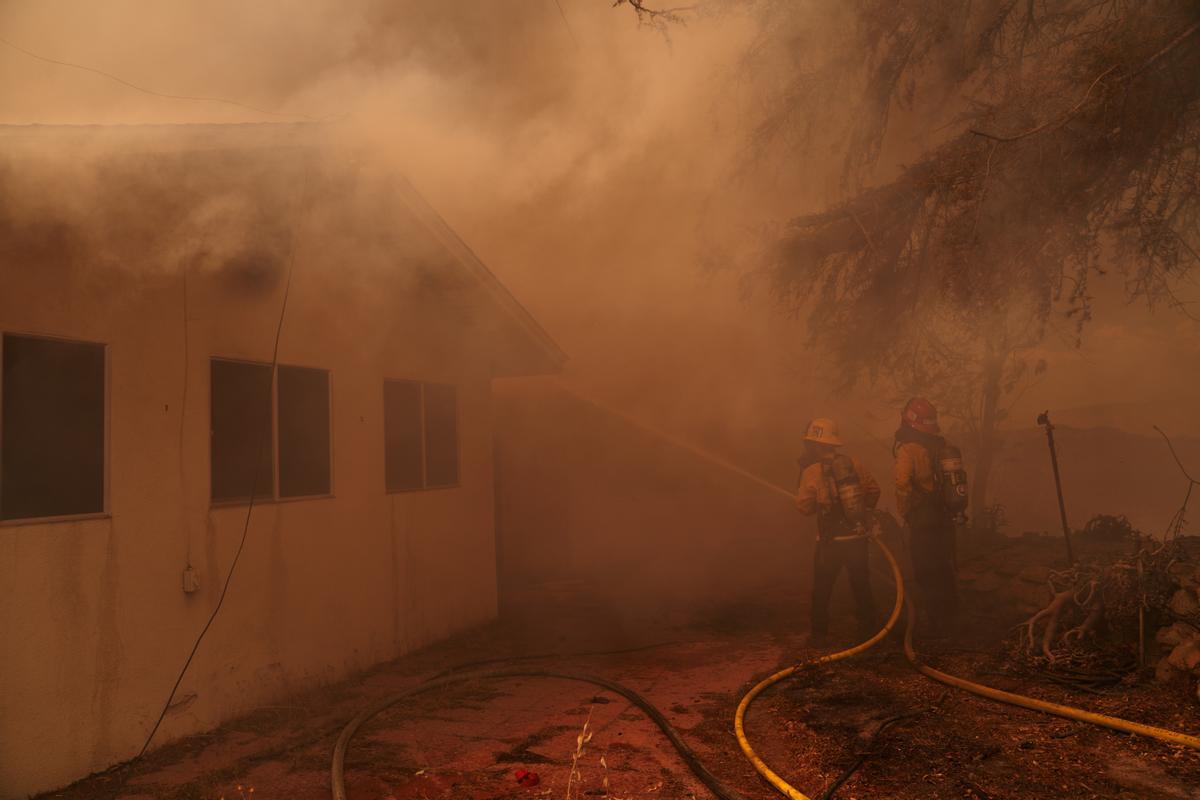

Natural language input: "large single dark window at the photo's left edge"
[0,335,104,519]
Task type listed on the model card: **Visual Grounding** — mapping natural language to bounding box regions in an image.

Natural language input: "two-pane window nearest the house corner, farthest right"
[384,380,458,492]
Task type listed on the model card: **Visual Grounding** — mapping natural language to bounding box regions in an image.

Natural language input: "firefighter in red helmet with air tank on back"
[892,397,966,636]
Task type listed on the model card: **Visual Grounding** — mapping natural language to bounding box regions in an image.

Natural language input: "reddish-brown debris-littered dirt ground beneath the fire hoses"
[32,546,1200,800]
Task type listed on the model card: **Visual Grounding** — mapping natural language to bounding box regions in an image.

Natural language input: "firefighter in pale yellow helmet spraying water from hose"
[796,417,880,646]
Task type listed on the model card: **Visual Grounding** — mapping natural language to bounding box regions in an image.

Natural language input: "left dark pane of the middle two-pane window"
[211,359,275,500]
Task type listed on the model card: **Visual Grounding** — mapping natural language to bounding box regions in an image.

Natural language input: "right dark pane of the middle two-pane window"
[278,367,330,498]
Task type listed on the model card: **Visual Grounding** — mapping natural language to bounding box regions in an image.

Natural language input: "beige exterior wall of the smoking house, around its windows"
[0,259,497,800]
